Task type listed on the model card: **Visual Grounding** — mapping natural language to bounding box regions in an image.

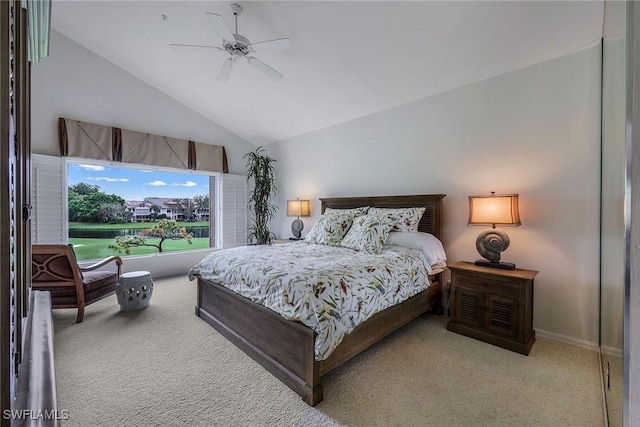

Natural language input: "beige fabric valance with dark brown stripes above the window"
[58,117,229,173]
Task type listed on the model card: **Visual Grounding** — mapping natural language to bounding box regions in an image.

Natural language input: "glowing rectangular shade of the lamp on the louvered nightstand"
[469,193,520,226]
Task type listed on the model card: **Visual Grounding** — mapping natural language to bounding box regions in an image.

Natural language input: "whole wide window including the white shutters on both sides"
[32,155,247,261]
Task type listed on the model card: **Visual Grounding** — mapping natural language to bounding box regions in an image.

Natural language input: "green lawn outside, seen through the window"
[69,237,209,261]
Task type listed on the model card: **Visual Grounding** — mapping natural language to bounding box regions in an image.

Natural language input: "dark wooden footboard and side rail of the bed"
[196,279,441,406]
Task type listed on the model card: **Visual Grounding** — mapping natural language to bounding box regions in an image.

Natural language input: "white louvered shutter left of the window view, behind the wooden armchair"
[31,154,68,243]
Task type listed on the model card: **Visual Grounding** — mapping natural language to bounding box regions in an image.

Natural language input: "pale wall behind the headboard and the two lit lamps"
[268,46,600,345]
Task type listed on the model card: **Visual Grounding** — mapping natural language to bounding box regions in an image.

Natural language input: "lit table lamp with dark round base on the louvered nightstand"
[468,191,520,270]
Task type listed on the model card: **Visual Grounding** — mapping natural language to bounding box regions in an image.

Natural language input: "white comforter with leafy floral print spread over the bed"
[189,242,429,360]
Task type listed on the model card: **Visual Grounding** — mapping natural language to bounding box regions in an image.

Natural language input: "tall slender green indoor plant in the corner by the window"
[243,147,278,245]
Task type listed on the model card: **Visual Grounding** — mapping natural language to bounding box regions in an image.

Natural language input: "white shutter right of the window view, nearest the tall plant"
[215,174,247,249]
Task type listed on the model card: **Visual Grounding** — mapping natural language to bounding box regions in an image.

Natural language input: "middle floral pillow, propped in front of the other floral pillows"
[340,215,394,253]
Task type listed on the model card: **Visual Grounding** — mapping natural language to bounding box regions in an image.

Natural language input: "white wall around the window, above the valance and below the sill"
[31,31,256,278]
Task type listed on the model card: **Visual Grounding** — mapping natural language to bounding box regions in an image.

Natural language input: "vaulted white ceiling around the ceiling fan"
[51,0,604,145]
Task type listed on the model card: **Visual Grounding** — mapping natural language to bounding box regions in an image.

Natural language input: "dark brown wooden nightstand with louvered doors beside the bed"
[447,262,538,355]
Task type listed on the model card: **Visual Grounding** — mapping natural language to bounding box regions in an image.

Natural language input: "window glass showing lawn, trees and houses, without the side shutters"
[67,161,210,260]
